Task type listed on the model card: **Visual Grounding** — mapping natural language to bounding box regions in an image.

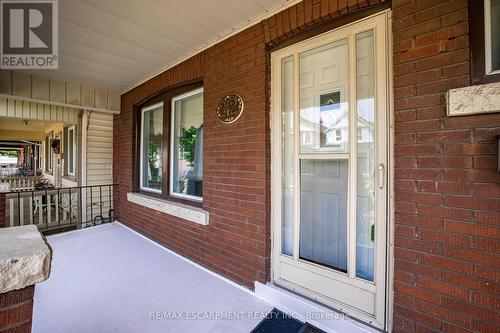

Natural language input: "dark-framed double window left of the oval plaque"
[134,82,203,206]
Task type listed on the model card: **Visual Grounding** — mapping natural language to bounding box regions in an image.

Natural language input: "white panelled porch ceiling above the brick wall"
[15,0,297,92]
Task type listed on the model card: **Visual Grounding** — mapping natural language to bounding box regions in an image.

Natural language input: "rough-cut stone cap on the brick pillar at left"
[0,225,52,294]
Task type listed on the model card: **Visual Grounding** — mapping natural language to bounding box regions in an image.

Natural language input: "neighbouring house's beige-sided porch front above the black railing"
[0,75,120,186]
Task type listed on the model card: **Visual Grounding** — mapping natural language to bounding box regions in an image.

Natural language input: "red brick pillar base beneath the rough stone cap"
[0,286,35,333]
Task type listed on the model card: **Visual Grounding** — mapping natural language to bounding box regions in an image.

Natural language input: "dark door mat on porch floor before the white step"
[251,308,325,333]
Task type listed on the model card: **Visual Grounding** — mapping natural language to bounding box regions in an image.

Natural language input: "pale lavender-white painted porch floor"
[33,222,272,333]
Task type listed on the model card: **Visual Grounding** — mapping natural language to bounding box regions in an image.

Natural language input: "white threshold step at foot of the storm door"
[255,282,385,333]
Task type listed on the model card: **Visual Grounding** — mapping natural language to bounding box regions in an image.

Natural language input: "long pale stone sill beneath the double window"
[127,192,209,225]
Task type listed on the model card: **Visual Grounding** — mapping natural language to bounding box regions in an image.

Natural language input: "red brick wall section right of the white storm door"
[392,0,500,332]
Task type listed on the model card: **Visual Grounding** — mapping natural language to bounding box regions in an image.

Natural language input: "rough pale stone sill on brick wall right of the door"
[446,82,500,116]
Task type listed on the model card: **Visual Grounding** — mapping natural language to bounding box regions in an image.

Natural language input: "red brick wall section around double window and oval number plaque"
[114,0,381,287]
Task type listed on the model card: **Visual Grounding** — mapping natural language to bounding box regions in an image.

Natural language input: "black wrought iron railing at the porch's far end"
[5,184,118,233]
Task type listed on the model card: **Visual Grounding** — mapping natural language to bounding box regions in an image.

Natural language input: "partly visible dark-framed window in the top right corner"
[468,0,500,84]
